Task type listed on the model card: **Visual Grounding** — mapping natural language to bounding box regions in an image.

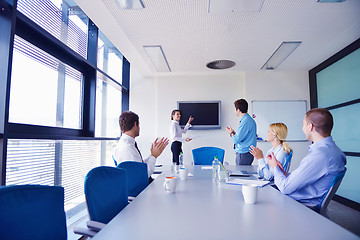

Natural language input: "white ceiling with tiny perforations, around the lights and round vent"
[75,0,360,76]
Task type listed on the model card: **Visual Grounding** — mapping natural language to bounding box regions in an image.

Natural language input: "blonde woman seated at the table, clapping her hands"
[250,123,291,180]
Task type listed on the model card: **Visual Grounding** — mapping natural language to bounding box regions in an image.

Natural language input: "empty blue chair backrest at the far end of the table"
[192,147,225,165]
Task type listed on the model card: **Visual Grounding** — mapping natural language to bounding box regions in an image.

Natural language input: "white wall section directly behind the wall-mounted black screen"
[158,74,245,164]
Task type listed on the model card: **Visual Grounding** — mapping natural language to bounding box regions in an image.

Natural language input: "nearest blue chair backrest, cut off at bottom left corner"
[0,185,67,240]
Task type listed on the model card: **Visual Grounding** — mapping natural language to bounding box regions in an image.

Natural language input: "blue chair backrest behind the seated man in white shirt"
[117,161,149,197]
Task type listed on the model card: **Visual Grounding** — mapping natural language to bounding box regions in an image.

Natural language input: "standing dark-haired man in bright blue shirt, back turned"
[226,99,256,165]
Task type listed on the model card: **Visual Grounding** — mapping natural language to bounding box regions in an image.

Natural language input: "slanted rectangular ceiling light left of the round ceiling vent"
[144,45,171,72]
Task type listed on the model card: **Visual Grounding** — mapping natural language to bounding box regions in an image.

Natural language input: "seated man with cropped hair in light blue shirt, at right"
[267,108,346,209]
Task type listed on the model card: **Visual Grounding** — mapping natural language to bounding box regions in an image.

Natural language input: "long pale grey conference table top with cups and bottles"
[93,165,360,240]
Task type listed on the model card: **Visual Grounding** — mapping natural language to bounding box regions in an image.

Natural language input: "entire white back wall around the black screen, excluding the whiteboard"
[130,69,309,172]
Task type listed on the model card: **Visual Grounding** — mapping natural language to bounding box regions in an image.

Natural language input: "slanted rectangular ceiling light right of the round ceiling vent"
[261,42,301,70]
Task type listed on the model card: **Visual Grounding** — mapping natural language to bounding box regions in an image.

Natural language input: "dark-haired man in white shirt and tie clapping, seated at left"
[113,111,169,177]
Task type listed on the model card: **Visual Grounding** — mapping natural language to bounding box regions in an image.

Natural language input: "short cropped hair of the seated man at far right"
[305,108,334,137]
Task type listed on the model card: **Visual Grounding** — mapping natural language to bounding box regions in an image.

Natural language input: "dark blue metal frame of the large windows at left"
[0,0,130,186]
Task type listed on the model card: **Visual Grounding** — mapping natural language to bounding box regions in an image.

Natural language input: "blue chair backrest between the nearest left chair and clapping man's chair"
[84,166,128,224]
